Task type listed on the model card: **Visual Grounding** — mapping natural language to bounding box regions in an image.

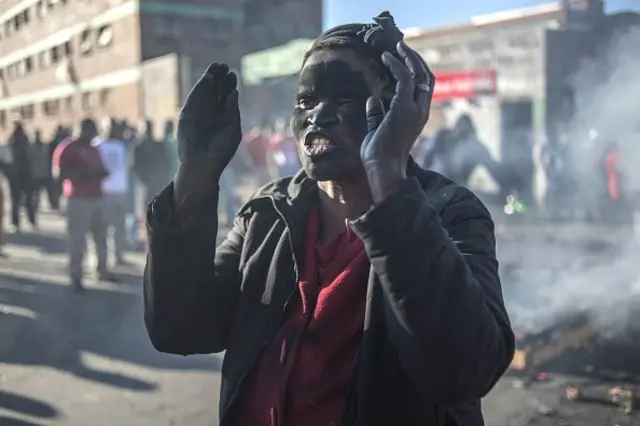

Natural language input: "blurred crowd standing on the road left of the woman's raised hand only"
[0,118,178,289]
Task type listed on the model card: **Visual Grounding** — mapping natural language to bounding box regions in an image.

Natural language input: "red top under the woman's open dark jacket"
[231,210,369,426]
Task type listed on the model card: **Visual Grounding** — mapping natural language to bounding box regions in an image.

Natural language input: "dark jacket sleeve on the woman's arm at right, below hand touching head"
[352,178,515,405]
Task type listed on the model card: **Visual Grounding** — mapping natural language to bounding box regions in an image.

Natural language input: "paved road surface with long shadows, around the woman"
[0,208,632,426]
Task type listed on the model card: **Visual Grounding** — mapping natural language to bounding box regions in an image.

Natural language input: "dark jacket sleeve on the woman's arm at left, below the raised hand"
[144,184,244,355]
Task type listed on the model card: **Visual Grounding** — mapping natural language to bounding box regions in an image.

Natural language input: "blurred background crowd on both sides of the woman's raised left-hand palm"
[0,117,300,289]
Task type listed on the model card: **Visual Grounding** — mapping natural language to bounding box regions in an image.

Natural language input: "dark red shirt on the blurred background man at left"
[51,139,104,197]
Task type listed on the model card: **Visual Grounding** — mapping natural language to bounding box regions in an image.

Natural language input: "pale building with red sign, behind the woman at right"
[407,0,606,204]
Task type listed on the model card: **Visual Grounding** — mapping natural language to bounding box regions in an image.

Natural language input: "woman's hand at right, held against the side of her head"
[360,41,435,201]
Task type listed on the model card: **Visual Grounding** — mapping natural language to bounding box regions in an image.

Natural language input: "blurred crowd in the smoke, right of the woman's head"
[412,115,632,221]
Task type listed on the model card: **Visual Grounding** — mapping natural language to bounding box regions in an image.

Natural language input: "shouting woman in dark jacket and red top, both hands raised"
[144,12,514,426]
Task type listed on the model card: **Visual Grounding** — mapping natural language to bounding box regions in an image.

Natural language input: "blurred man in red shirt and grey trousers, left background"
[52,119,115,290]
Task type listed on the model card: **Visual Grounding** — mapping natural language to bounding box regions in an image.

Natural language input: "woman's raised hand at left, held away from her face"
[174,63,242,209]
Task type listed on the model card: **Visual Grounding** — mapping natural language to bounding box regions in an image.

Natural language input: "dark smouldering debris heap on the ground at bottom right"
[502,313,640,426]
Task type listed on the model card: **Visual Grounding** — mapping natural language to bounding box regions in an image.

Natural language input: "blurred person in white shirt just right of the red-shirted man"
[95,118,130,264]
